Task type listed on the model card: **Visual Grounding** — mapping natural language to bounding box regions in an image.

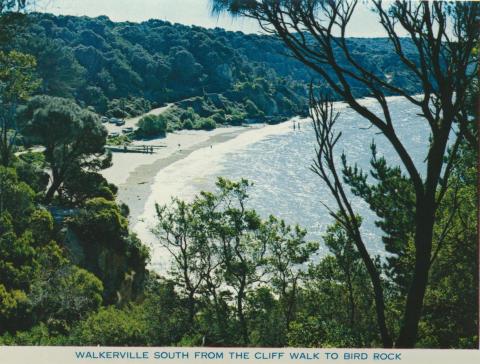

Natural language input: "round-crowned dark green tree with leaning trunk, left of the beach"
[22,96,111,203]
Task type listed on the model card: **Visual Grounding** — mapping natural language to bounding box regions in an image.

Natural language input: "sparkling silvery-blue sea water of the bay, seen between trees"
[138,97,429,270]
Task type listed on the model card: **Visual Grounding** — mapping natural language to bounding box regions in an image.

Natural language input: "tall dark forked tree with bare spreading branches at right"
[214,0,479,347]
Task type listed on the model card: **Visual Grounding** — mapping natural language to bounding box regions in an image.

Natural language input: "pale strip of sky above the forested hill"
[35,0,394,37]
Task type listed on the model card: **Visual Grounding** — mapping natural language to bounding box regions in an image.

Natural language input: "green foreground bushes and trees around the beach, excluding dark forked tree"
[0,0,478,348]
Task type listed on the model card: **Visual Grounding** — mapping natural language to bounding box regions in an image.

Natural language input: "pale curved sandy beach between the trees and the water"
[102,112,306,272]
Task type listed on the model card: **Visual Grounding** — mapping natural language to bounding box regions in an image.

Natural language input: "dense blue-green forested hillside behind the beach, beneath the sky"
[7,14,419,123]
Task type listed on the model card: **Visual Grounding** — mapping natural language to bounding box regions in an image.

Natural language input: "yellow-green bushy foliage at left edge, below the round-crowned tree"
[0,167,74,333]
